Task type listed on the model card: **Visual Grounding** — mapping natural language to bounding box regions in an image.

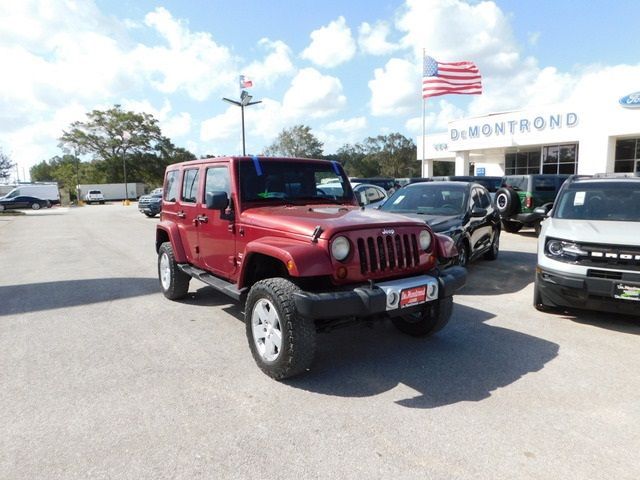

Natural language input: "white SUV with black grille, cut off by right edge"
[533,174,640,315]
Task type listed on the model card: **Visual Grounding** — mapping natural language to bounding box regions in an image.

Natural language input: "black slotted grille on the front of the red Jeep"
[357,233,420,273]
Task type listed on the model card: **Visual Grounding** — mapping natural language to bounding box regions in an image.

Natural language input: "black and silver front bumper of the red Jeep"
[294,267,467,320]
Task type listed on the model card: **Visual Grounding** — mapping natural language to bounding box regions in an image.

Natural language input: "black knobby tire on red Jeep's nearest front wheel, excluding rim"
[244,278,316,380]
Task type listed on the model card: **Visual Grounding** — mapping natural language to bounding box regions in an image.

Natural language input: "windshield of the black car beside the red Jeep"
[380,182,468,216]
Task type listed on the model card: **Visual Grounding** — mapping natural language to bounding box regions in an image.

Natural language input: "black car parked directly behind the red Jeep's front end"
[380,182,500,266]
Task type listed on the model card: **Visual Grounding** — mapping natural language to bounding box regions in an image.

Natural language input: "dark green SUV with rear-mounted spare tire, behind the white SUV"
[495,174,569,234]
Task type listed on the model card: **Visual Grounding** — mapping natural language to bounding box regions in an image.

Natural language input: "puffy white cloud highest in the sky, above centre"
[301,17,356,68]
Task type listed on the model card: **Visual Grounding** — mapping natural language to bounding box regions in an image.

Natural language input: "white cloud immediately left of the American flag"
[369,58,420,116]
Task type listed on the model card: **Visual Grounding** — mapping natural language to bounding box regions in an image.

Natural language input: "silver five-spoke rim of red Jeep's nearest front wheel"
[251,298,282,362]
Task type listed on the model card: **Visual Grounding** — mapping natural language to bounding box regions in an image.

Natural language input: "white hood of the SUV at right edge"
[545,218,640,245]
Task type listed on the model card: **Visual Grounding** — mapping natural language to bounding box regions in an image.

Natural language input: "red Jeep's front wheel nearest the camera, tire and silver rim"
[245,278,316,380]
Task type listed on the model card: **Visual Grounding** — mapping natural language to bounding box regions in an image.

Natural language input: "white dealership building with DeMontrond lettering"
[417,92,640,177]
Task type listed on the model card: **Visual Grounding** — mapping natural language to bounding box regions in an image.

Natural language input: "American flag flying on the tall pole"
[422,56,482,98]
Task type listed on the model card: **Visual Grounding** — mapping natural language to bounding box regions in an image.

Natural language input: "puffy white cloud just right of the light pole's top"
[282,68,347,118]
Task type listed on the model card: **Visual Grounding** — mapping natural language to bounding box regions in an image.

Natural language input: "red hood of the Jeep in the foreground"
[240,205,424,239]
